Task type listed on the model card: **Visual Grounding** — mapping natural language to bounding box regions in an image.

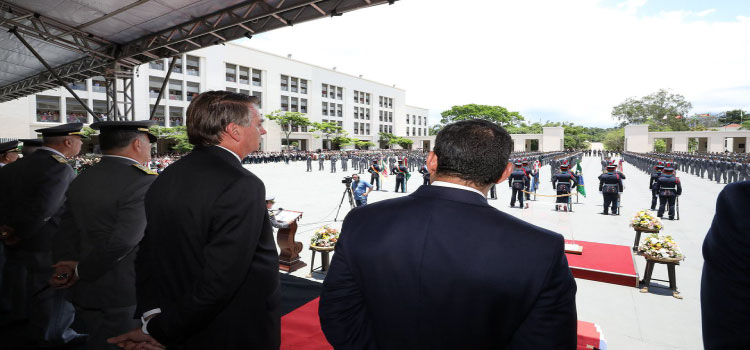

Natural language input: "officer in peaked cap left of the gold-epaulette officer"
[0,123,84,346]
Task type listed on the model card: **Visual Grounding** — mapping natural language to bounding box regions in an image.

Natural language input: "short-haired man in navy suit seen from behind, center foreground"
[319,120,577,350]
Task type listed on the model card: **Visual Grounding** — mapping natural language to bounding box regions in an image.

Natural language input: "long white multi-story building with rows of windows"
[0,43,431,151]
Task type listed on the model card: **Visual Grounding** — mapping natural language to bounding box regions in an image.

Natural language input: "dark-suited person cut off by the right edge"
[701,181,750,349]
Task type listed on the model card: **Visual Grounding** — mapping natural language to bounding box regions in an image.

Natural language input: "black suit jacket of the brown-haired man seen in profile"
[136,146,280,349]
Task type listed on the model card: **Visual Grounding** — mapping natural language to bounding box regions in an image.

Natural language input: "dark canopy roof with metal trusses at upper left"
[0,0,393,102]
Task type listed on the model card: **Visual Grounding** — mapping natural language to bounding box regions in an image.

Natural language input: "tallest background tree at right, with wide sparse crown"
[612,89,693,131]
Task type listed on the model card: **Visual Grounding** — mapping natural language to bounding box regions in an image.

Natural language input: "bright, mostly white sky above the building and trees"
[241,0,750,127]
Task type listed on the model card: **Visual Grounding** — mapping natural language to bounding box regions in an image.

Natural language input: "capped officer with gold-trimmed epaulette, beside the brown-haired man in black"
[50,120,156,349]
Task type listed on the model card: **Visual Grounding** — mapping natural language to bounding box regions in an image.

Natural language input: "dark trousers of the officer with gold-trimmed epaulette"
[76,305,141,350]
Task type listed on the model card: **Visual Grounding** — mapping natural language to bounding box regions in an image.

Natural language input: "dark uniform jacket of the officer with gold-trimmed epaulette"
[53,156,156,309]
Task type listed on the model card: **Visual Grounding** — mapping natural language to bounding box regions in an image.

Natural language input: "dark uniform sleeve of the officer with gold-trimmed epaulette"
[78,178,155,281]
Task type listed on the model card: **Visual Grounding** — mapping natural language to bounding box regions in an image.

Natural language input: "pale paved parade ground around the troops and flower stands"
[246,157,724,349]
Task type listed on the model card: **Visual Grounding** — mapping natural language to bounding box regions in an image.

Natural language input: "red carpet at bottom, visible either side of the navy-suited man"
[281,298,602,350]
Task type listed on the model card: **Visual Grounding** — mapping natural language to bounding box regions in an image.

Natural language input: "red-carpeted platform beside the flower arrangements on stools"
[565,240,638,287]
